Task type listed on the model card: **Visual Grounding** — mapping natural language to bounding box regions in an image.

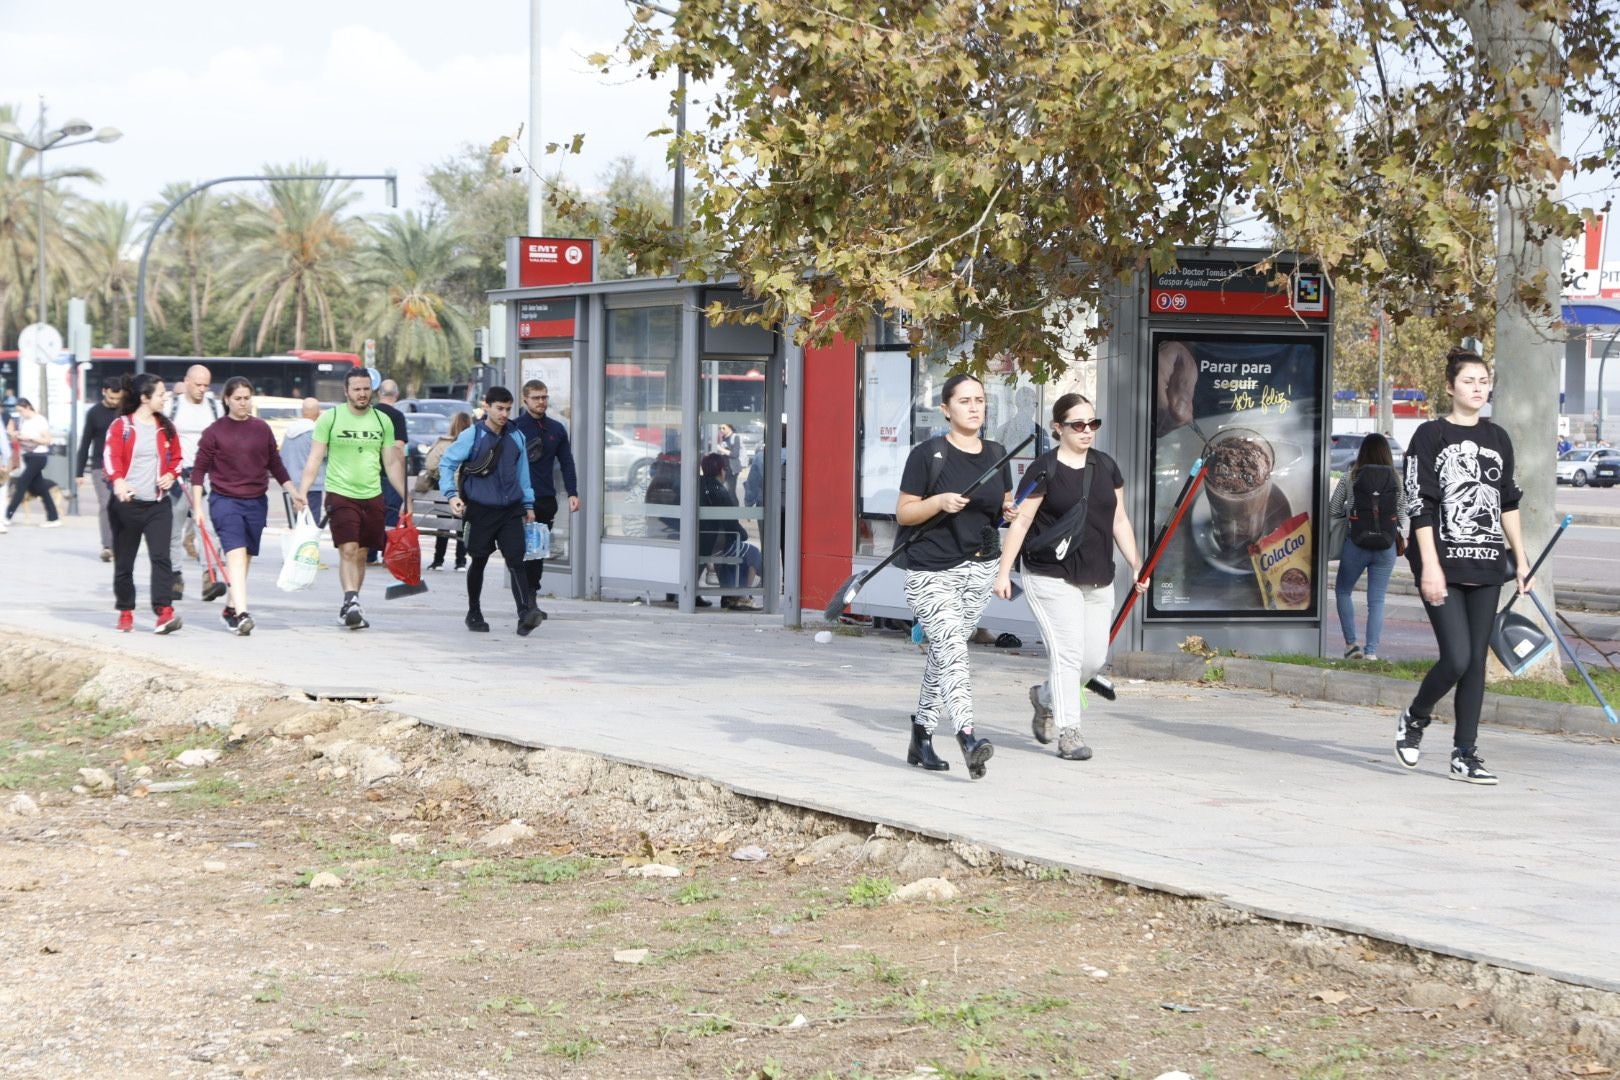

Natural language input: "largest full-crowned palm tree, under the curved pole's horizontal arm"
[225,162,360,351]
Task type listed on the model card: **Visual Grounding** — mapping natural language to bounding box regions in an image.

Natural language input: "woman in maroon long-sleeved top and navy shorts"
[191,376,306,638]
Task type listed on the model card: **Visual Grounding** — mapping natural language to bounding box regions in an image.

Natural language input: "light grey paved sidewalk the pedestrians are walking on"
[9,518,1620,989]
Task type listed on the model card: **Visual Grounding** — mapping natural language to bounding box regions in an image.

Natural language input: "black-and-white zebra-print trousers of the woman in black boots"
[906,559,996,735]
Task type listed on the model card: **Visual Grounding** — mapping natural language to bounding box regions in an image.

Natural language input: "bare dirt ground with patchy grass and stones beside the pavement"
[0,651,1620,1080]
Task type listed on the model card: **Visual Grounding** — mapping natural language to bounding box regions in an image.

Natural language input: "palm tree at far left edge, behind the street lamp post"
[0,105,100,342]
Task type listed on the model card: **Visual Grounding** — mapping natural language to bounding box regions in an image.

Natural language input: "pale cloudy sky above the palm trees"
[0,0,669,220]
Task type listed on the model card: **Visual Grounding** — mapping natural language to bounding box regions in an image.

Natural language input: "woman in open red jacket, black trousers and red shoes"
[102,372,181,633]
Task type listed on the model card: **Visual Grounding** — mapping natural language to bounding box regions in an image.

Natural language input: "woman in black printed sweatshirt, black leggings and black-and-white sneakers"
[1395,348,1533,784]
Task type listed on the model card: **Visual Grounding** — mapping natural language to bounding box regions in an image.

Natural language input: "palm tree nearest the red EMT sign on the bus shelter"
[358,210,478,393]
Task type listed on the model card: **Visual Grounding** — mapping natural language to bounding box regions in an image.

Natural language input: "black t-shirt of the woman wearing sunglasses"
[1021,450,1124,585]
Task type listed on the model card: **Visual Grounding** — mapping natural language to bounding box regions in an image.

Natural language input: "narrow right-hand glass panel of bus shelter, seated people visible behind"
[695,356,771,602]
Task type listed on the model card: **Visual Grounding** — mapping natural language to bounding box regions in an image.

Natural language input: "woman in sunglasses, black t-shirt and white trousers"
[995,393,1147,761]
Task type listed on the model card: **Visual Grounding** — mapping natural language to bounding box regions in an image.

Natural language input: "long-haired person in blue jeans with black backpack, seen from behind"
[1327,432,1408,661]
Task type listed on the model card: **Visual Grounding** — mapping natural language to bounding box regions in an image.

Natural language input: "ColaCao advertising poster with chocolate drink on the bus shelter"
[1144,330,1327,622]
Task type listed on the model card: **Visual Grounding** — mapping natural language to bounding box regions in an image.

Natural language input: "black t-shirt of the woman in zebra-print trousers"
[901,439,1013,570]
